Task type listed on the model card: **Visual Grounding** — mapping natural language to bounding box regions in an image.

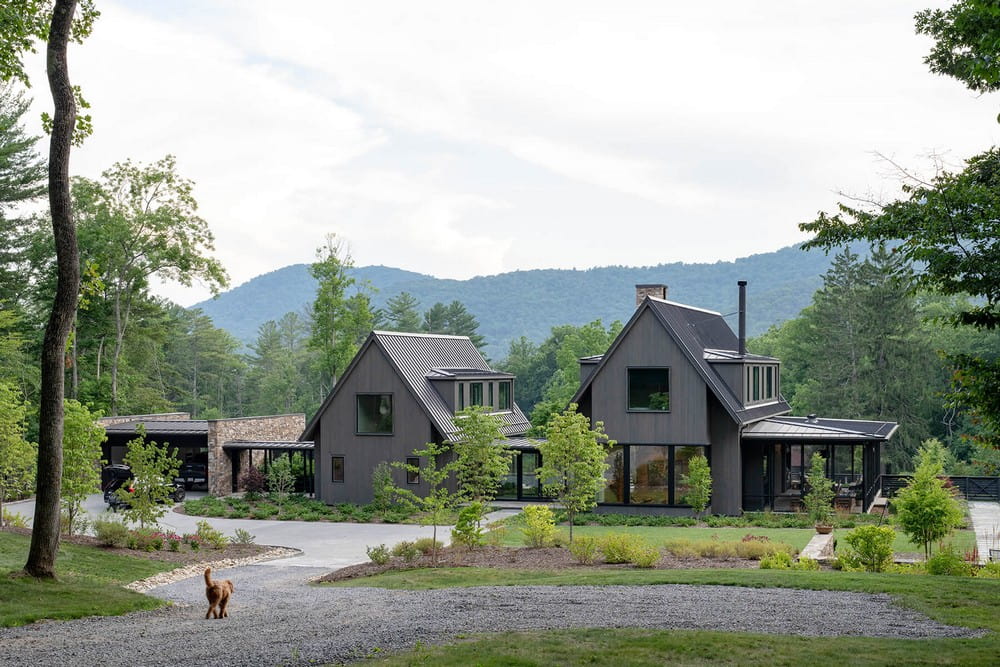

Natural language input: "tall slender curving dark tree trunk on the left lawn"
[24,0,80,578]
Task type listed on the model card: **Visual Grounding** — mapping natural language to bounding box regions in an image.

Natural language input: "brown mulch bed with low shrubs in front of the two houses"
[317,547,760,582]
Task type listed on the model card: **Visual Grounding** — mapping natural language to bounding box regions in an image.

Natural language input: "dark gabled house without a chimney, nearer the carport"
[302,331,537,504]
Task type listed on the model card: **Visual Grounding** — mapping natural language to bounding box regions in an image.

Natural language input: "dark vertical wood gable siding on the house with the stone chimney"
[590,310,711,445]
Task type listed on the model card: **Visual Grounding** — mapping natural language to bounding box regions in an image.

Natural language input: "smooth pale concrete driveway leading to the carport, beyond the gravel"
[5,492,440,570]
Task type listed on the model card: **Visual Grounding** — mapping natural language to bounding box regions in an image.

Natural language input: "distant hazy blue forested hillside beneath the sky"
[193,246,864,359]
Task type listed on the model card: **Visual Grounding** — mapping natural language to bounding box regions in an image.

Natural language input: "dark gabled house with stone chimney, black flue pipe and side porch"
[573,281,896,514]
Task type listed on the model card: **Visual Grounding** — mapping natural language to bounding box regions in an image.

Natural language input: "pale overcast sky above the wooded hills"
[23,0,1000,305]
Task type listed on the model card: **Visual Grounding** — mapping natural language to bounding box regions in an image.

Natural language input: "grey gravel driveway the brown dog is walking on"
[0,562,980,667]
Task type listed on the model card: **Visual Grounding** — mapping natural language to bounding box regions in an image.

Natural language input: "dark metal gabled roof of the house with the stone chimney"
[573,296,791,424]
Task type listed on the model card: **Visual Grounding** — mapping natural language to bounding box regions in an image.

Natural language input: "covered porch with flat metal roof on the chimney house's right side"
[740,415,898,513]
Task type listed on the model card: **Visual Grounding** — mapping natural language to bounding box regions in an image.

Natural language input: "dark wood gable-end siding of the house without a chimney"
[316,344,434,505]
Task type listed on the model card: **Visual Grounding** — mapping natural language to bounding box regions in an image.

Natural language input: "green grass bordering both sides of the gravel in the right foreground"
[342,568,1000,665]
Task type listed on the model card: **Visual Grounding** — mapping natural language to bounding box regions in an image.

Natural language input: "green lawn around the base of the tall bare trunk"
[0,531,174,627]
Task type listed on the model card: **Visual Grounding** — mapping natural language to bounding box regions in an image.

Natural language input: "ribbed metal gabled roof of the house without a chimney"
[302,331,531,440]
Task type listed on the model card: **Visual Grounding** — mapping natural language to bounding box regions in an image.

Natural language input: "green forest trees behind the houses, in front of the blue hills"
[0,72,1000,473]
